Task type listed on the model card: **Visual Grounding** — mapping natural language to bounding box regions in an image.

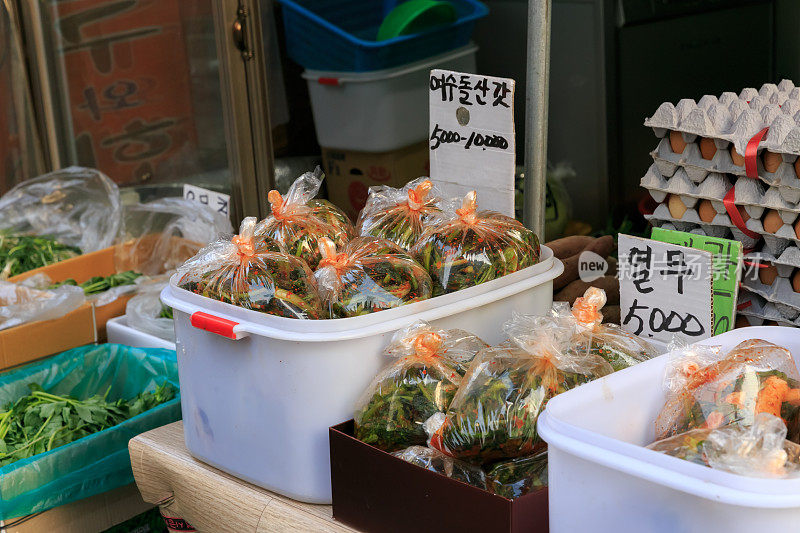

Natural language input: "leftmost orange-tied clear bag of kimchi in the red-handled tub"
[178,217,326,319]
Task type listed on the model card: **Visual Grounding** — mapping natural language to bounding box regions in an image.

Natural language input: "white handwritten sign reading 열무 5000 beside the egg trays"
[619,235,714,343]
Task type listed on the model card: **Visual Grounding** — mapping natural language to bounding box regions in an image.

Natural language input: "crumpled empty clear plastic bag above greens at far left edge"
[0,167,121,253]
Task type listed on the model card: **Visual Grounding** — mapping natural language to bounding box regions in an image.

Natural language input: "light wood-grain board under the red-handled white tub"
[128,422,355,533]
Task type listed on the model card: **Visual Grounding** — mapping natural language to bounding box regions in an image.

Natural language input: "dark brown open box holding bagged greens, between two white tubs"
[329,420,548,533]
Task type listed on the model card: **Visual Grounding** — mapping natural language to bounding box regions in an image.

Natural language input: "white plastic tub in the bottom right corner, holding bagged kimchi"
[538,327,800,533]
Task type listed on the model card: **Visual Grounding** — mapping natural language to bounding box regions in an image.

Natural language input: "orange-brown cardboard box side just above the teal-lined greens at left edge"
[0,303,97,370]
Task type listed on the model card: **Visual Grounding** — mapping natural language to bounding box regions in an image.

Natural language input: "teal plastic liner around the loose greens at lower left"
[0,344,181,520]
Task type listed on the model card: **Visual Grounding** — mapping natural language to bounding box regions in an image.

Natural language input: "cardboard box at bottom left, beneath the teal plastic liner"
[0,483,153,533]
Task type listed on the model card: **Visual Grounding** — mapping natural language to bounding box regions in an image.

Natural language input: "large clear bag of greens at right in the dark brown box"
[430,315,613,464]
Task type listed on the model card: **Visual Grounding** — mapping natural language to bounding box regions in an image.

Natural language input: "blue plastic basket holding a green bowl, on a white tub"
[278,0,489,72]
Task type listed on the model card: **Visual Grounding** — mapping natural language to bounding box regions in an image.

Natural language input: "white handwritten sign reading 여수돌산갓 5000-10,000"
[429,69,516,217]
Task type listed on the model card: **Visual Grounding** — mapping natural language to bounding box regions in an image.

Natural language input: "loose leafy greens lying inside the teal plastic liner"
[0,383,176,467]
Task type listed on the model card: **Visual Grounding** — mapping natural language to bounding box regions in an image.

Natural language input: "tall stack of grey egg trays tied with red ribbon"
[641,80,800,326]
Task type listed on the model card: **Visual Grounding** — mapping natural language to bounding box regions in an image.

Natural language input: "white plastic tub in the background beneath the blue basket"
[303,45,478,152]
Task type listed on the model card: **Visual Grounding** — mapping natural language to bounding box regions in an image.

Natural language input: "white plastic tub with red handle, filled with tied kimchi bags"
[161,246,564,503]
